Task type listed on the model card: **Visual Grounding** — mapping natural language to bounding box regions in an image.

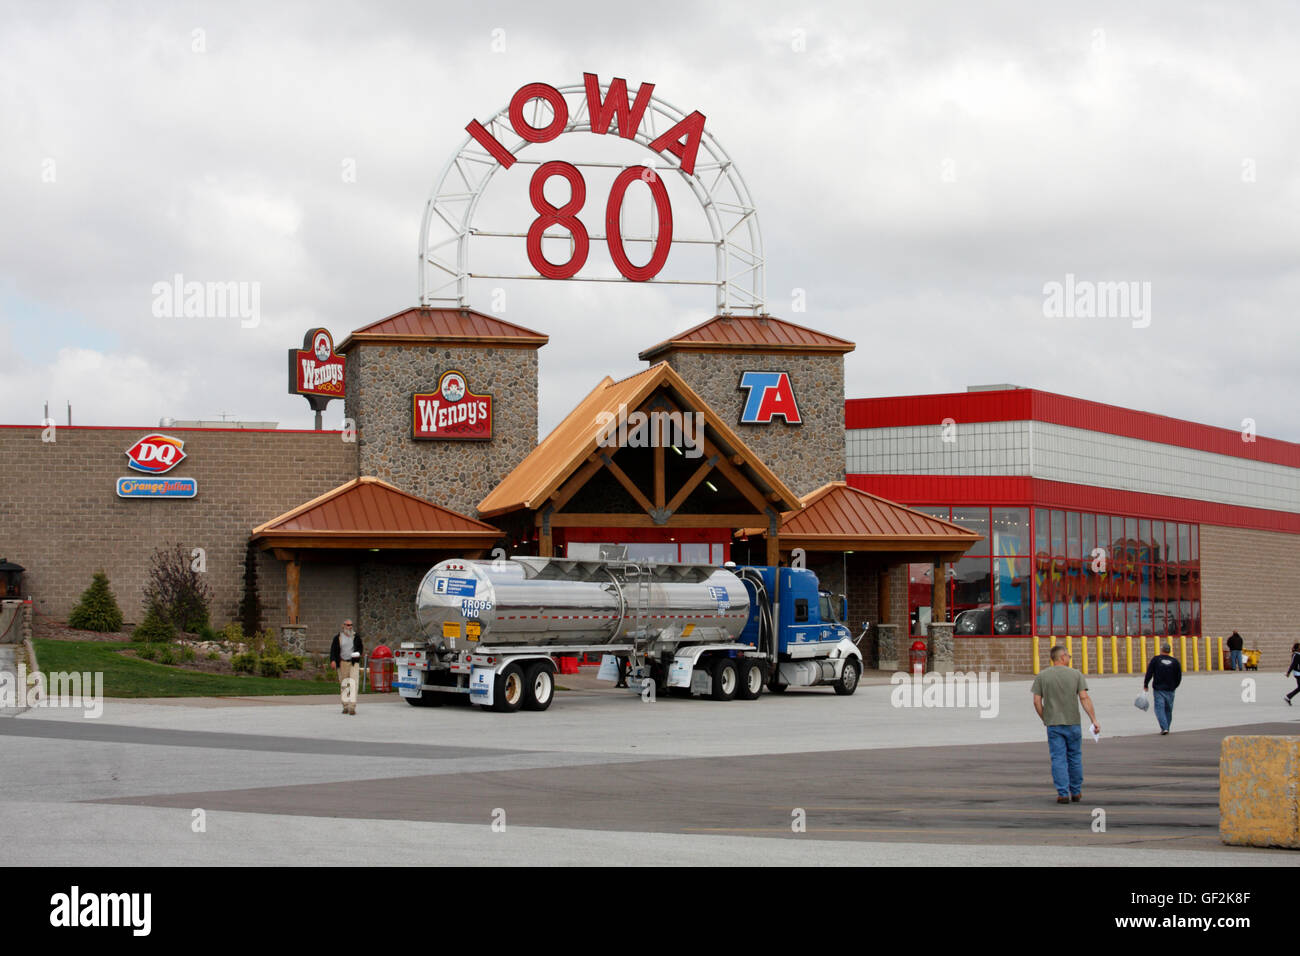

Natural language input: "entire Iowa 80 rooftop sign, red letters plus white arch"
[420,73,764,313]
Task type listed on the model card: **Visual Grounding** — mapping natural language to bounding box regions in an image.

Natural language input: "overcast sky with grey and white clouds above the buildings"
[0,0,1300,441]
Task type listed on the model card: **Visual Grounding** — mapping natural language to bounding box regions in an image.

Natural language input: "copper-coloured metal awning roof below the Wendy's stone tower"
[252,476,502,548]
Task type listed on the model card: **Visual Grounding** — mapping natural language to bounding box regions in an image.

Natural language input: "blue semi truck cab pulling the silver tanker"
[732,566,863,695]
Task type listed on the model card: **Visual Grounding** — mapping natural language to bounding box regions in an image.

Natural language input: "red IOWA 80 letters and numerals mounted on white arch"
[465,73,705,282]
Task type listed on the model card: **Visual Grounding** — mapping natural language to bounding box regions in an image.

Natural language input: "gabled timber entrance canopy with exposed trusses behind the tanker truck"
[478,363,800,557]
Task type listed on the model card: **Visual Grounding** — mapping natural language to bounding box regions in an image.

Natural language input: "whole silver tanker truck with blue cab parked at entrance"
[394,557,862,713]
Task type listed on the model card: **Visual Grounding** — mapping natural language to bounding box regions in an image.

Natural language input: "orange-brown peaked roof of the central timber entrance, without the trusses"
[478,362,798,516]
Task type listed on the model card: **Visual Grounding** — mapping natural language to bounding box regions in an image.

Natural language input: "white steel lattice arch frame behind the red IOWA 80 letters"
[419,83,767,315]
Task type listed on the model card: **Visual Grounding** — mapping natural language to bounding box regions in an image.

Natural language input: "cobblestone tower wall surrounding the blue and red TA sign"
[663,350,846,496]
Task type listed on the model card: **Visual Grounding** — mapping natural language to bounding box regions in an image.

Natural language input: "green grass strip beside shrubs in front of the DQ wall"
[33,639,338,697]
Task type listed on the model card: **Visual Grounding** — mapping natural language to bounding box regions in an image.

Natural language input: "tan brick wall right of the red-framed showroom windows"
[1201,524,1300,672]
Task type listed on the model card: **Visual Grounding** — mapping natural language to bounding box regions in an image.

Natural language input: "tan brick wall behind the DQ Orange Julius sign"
[0,427,356,645]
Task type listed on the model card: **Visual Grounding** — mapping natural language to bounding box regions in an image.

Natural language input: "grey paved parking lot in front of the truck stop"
[0,674,1297,866]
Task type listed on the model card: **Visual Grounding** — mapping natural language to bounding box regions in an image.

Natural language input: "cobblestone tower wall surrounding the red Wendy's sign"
[345,342,537,516]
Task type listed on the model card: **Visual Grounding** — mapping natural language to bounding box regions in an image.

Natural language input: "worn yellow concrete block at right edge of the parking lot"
[1219,735,1300,849]
